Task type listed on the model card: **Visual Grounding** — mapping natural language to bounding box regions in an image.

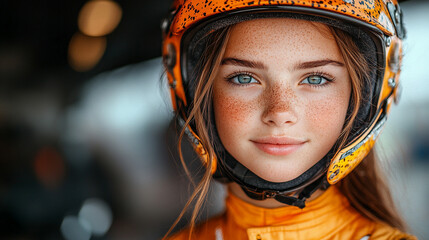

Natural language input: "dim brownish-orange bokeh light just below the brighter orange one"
[69,33,106,72]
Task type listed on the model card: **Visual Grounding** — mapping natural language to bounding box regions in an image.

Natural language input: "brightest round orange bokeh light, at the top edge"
[78,0,122,37]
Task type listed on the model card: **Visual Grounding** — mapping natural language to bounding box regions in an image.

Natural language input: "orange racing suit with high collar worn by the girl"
[169,186,417,240]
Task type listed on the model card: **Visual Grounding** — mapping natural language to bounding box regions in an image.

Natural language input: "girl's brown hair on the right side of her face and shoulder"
[331,28,405,231]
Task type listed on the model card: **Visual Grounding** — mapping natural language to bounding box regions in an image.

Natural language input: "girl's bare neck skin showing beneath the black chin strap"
[228,182,324,208]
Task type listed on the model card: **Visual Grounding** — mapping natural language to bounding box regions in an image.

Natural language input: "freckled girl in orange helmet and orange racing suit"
[163,0,414,240]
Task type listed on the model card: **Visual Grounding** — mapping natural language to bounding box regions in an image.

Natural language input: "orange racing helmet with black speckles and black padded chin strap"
[162,0,405,208]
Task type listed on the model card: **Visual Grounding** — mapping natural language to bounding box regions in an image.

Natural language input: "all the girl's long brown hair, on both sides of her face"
[166,22,405,239]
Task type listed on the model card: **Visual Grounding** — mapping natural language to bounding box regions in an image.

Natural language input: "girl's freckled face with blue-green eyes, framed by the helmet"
[213,18,351,182]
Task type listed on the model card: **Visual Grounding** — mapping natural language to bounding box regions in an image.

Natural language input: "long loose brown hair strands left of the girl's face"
[164,27,230,239]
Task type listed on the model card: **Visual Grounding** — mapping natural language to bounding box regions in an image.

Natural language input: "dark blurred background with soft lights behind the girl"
[0,0,429,240]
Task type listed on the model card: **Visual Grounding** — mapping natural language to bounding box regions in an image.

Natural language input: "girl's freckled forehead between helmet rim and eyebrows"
[225,18,341,63]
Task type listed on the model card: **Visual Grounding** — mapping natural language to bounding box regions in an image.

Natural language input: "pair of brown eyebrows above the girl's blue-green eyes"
[221,57,344,70]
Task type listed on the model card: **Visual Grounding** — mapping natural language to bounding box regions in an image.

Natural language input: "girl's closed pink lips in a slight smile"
[251,137,306,156]
